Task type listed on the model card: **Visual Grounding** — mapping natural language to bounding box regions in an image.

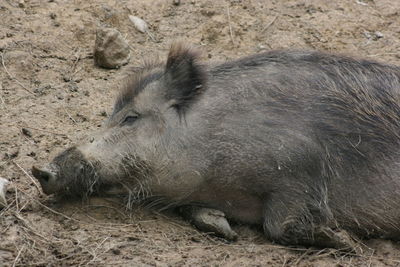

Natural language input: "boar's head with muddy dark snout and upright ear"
[32,43,206,205]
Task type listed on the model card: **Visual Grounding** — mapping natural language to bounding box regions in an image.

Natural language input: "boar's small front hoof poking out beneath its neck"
[180,206,237,241]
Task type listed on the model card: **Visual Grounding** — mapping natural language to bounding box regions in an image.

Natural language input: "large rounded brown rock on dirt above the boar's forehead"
[93,28,130,69]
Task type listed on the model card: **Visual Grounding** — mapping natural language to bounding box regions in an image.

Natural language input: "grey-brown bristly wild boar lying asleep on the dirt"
[32,43,400,251]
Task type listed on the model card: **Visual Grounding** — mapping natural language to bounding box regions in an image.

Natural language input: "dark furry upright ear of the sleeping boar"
[165,43,206,114]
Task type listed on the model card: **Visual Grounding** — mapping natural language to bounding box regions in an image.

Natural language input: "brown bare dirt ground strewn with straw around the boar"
[0,0,400,266]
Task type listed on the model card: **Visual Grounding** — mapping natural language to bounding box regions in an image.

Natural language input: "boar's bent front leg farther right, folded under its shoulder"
[264,192,361,253]
